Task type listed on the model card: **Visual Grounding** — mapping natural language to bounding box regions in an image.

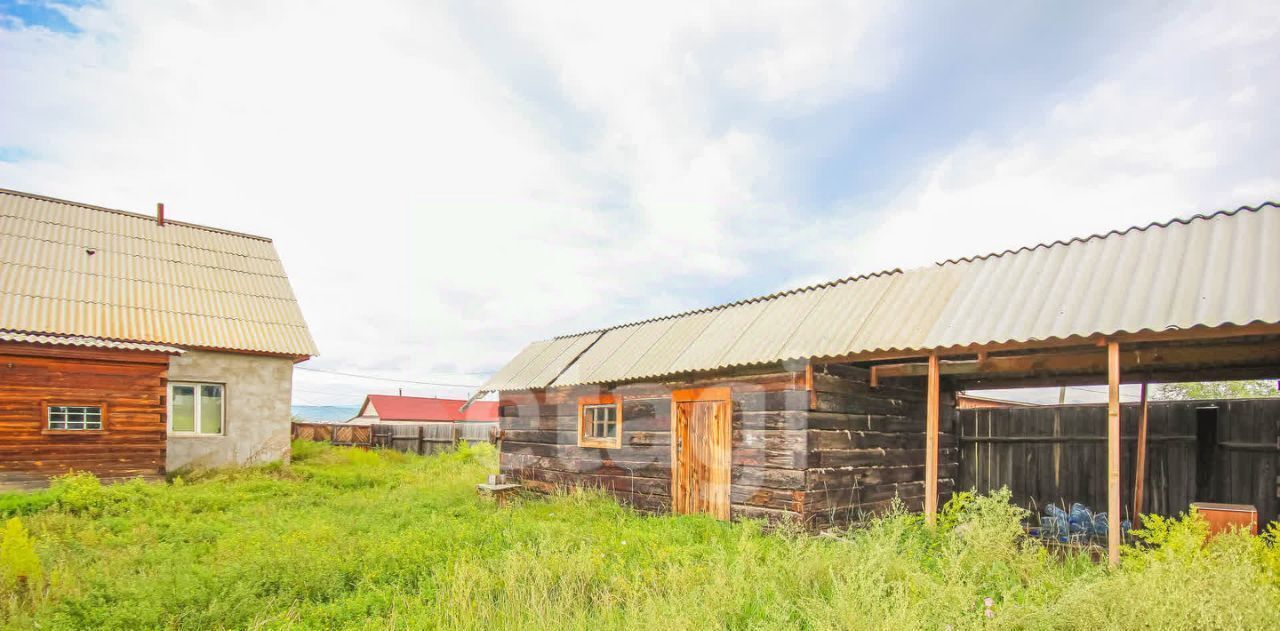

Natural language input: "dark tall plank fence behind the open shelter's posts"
[956,399,1280,523]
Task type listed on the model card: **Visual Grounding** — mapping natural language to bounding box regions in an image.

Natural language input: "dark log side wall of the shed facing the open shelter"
[804,366,959,527]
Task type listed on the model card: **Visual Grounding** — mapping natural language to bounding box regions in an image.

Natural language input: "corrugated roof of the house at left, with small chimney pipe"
[0,189,316,356]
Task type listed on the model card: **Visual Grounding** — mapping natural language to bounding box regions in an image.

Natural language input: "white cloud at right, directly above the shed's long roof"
[808,4,1280,275]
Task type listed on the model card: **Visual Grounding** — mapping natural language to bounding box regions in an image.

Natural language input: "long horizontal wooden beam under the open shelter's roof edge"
[873,342,1280,379]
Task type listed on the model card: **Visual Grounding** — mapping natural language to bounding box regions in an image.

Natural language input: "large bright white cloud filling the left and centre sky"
[0,0,901,403]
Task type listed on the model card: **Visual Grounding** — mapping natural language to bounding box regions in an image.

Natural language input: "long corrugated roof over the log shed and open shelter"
[484,202,1280,390]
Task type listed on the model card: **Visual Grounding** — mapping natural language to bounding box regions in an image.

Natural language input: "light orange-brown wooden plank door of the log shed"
[671,388,733,520]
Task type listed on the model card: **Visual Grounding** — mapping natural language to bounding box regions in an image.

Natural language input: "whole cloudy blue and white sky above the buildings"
[0,0,1280,404]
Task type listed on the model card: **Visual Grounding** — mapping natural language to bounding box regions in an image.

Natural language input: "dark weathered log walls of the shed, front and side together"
[499,366,957,527]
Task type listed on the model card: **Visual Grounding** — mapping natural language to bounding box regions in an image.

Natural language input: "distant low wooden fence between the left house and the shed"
[291,422,498,454]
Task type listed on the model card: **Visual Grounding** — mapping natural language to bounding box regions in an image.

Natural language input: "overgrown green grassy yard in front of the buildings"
[0,443,1280,630]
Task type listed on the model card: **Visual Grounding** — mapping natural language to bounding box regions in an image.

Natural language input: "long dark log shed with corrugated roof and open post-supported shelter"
[484,202,1280,553]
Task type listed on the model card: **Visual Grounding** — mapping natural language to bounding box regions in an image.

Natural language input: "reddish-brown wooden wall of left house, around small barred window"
[0,344,169,488]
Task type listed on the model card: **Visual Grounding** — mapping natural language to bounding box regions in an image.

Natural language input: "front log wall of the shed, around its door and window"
[499,369,809,520]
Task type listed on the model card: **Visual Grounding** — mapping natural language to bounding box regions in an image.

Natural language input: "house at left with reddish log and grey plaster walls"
[0,189,316,488]
